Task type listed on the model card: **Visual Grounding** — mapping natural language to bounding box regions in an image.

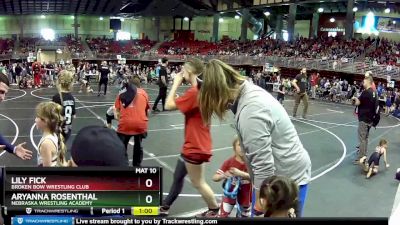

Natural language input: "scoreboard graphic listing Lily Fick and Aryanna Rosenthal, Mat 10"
[0,167,162,216]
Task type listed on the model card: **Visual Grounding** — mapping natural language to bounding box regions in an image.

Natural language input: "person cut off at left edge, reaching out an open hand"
[0,72,32,160]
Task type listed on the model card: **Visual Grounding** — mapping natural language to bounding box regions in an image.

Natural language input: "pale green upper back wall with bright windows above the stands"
[0,15,254,41]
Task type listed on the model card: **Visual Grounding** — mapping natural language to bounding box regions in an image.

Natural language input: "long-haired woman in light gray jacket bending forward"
[199,60,311,216]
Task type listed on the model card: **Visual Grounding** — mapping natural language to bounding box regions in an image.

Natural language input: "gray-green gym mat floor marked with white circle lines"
[0,85,400,217]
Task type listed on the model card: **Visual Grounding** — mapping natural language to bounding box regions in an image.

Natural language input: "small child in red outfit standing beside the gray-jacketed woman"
[213,138,251,217]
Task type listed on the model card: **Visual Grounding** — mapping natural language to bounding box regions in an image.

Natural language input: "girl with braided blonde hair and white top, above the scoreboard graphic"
[35,102,66,167]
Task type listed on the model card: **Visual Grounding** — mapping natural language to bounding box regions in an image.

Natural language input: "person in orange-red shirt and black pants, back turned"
[114,77,150,167]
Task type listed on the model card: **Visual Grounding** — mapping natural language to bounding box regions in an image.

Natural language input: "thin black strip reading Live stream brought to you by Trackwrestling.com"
[7,216,388,225]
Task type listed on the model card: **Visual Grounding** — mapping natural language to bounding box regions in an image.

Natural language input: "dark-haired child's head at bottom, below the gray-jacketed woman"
[260,176,299,217]
